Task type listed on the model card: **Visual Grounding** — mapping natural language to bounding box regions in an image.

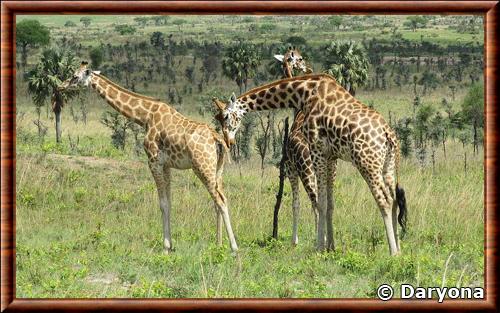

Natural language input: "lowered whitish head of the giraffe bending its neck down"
[212,93,246,146]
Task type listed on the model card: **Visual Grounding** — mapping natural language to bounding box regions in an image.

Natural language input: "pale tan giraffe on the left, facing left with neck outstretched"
[60,62,238,253]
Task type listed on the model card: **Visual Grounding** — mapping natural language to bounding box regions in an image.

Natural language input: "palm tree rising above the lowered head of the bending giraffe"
[222,41,260,94]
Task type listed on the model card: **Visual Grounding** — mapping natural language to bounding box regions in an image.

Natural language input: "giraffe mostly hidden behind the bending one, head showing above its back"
[274,47,326,245]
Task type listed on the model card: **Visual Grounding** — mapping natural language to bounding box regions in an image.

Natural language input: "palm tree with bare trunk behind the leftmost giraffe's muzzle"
[27,50,79,142]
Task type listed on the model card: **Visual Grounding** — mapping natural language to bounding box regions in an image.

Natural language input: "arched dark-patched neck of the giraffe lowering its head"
[238,74,330,112]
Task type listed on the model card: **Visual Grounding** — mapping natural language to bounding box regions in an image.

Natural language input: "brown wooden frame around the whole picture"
[1,0,499,312]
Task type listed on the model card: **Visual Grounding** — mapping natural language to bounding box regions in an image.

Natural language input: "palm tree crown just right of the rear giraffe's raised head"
[324,41,368,96]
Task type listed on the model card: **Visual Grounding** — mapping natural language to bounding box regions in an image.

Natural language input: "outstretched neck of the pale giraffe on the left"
[90,73,158,126]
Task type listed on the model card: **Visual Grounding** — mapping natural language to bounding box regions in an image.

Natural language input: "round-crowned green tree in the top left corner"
[16,20,50,68]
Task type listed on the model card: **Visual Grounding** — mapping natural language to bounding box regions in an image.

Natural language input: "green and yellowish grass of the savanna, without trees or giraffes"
[16,15,484,298]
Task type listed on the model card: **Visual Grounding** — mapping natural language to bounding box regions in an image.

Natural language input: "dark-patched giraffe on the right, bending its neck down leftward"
[214,74,407,255]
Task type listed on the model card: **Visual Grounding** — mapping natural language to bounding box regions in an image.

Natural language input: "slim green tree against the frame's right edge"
[461,83,484,153]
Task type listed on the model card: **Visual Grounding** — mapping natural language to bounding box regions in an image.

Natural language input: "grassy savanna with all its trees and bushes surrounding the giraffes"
[16,15,484,298]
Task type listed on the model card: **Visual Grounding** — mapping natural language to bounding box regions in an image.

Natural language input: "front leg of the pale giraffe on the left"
[149,161,172,253]
